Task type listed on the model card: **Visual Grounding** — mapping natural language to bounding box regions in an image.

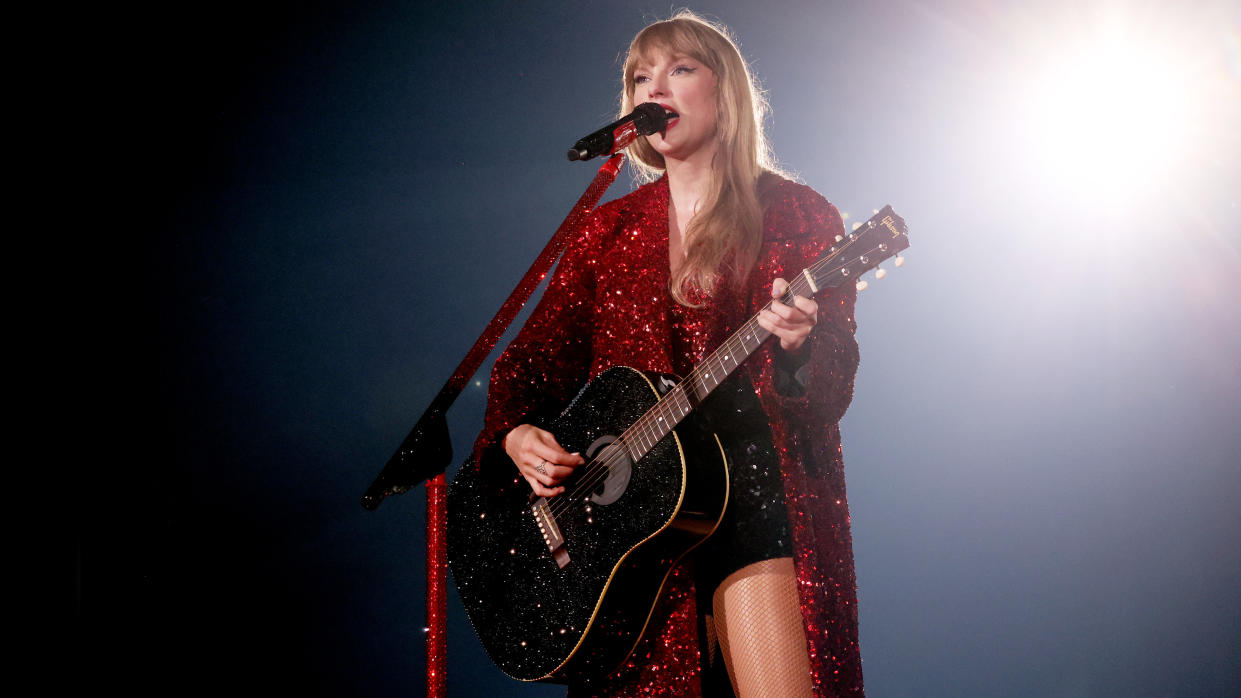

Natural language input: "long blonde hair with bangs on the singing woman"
[621,10,777,307]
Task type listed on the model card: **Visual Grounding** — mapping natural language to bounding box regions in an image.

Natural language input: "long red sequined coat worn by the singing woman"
[475,172,861,697]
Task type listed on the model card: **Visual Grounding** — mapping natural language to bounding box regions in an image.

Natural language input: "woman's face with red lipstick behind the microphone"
[633,50,716,163]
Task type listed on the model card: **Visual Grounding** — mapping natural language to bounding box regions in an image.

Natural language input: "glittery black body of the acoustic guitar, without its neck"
[448,368,728,682]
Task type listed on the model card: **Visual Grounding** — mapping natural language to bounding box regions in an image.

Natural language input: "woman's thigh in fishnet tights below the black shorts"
[711,558,814,698]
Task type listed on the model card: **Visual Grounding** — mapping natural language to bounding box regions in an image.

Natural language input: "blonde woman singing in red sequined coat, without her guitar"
[478,12,861,697]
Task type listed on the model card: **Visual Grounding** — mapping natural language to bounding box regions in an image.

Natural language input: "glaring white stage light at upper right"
[1023,20,1196,197]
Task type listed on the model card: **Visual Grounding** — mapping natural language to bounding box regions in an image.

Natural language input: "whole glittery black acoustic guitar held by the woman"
[448,206,910,683]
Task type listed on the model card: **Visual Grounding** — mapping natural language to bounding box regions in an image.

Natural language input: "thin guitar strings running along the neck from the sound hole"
[547,235,884,515]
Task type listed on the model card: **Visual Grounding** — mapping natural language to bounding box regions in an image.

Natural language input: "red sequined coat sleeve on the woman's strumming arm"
[474,206,609,457]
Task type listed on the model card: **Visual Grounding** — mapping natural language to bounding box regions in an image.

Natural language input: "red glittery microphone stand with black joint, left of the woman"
[362,153,624,698]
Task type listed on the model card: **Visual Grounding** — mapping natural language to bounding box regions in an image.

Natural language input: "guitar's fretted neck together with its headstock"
[618,206,910,462]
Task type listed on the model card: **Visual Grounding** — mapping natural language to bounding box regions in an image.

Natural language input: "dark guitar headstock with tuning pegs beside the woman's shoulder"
[802,206,910,291]
